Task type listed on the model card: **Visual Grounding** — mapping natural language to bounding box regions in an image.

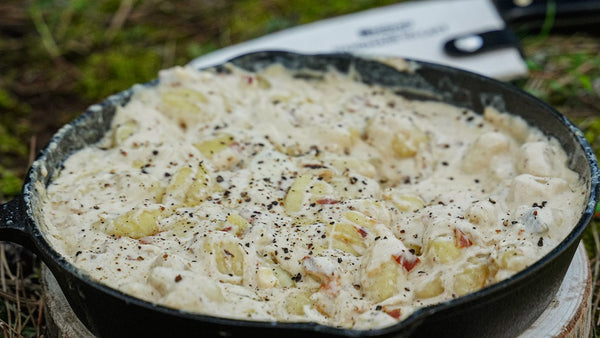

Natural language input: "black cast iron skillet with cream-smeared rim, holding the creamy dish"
[0,52,599,337]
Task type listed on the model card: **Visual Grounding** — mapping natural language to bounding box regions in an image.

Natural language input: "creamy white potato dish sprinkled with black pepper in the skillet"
[43,65,585,329]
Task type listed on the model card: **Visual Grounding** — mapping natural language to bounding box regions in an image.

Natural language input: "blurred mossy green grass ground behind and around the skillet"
[0,0,600,337]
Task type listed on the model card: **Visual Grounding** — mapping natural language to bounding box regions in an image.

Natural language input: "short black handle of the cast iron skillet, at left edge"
[0,196,35,249]
